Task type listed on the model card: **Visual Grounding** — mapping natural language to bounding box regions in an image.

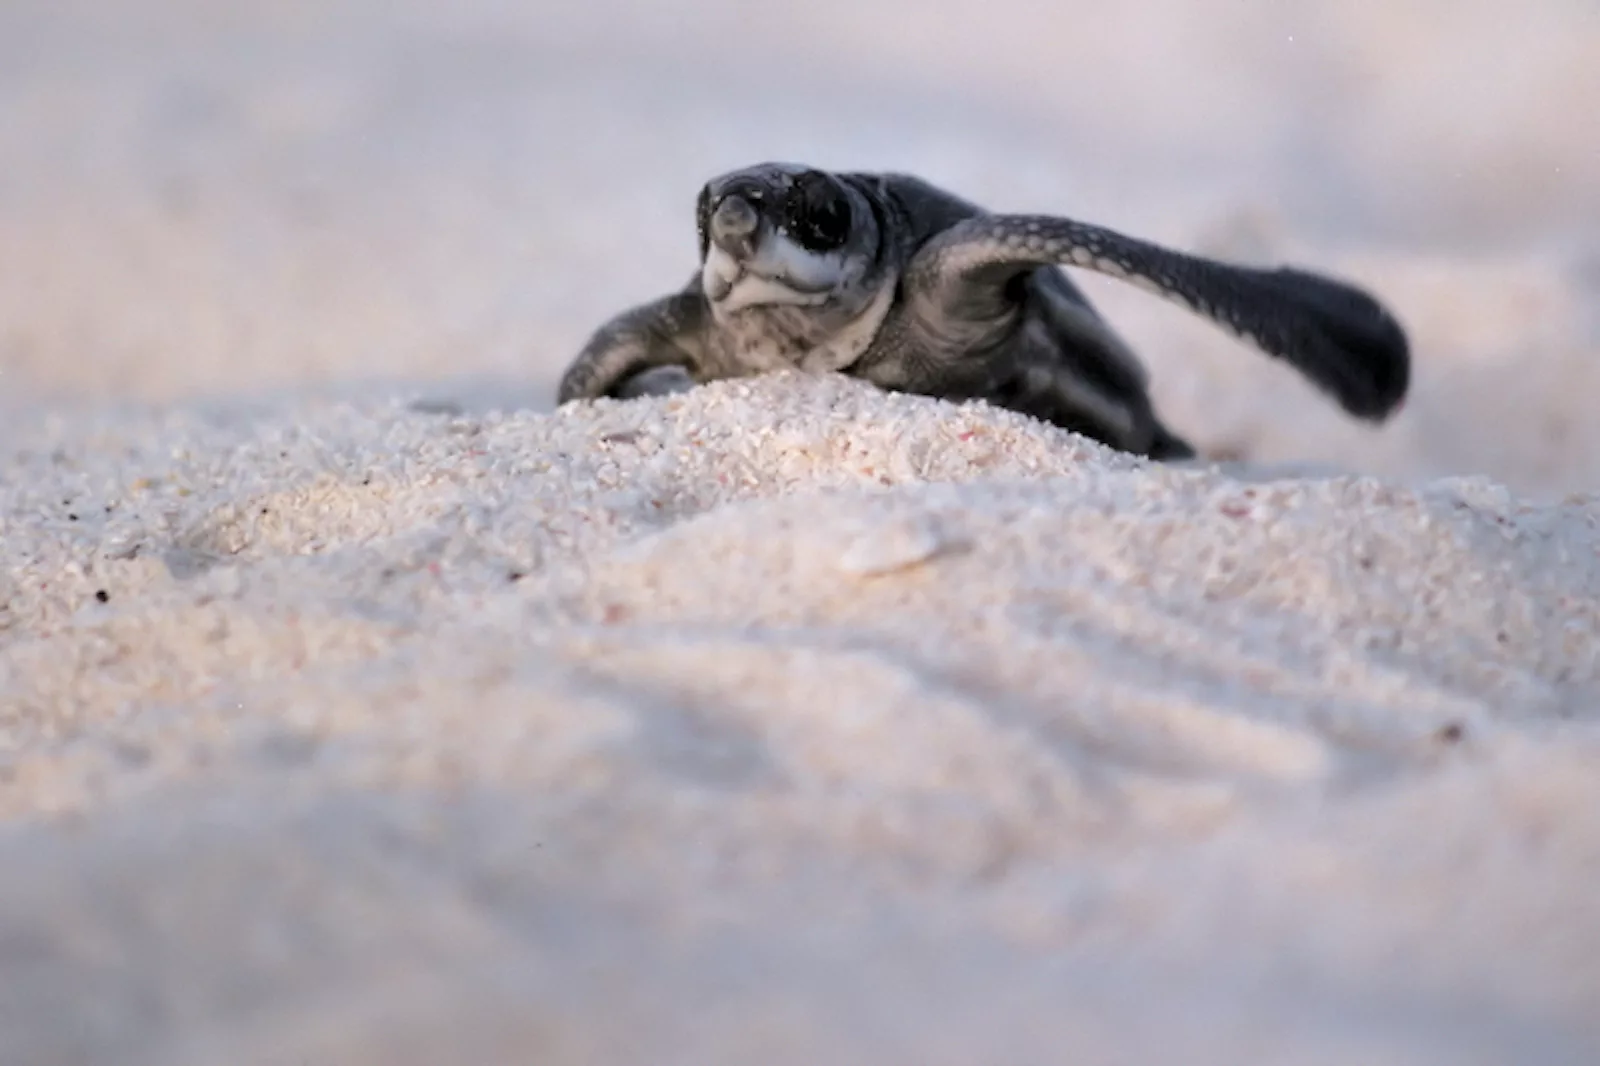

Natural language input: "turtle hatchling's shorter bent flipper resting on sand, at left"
[555,290,710,405]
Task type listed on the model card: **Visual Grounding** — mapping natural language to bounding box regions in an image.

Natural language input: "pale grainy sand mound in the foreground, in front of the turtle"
[0,375,1600,1064]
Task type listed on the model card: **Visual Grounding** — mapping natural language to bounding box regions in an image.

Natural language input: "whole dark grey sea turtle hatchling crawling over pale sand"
[557,163,1410,459]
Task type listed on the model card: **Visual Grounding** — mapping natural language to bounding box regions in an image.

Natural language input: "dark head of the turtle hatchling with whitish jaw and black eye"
[696,163,878,314]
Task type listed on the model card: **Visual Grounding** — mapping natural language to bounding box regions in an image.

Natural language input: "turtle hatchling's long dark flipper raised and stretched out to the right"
[906,214,1411,421]
